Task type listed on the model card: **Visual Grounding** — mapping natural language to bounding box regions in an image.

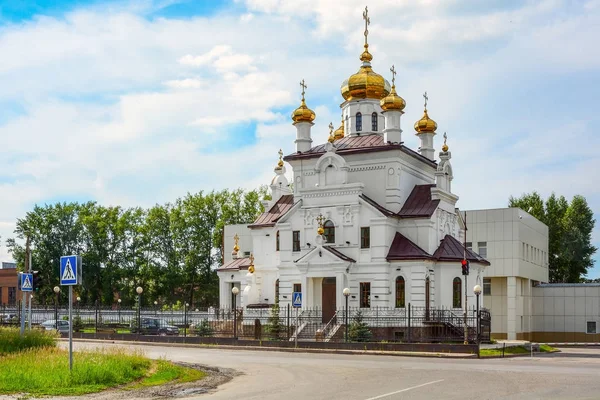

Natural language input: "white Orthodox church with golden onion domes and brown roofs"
[218,9,489,321]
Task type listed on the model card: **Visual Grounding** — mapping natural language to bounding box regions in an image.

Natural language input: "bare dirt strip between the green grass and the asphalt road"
[0,362,241,400]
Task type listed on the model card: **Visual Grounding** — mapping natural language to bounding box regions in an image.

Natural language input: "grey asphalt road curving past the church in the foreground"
[68,342,600,400]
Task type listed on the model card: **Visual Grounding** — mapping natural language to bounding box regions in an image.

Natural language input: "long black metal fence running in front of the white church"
[0,304,491,343]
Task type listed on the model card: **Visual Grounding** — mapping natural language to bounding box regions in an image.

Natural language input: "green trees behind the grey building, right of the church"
[509,192,597,283]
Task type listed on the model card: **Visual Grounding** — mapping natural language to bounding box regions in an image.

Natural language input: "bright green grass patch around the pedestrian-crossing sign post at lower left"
[0,347,152,396]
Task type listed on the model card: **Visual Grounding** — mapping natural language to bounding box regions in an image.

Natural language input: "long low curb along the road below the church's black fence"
[59,338,477,359]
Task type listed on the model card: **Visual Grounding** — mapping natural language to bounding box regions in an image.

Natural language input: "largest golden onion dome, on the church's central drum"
[341,44,391,101]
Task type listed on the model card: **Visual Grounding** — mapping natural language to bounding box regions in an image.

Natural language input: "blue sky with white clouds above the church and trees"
[0,0,600,278]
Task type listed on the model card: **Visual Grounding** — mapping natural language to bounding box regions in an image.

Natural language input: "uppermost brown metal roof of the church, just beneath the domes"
[283,134,437,168]
